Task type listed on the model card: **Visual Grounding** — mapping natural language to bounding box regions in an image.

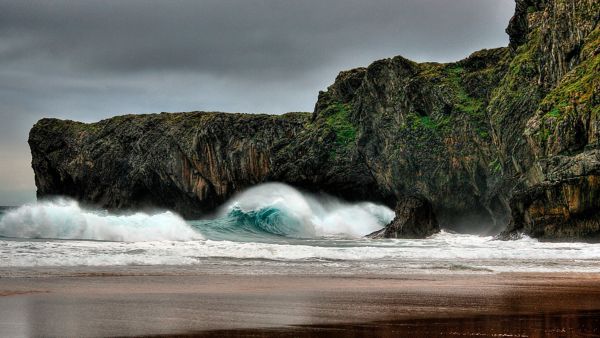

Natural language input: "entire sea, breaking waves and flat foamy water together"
[0,183,600,275]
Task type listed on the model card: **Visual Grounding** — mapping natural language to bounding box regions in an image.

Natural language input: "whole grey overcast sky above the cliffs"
[0,0,514,205]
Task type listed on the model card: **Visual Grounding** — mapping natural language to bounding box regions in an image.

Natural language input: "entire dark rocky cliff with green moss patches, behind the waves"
[29,0,600,238]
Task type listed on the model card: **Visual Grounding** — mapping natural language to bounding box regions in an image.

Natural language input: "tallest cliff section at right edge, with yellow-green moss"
[498,1,600,239]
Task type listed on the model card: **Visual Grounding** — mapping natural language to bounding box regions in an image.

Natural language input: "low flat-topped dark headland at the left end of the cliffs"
[29,112,310,217]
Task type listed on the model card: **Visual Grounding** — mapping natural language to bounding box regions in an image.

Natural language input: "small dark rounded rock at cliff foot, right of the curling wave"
[367,196,440,239]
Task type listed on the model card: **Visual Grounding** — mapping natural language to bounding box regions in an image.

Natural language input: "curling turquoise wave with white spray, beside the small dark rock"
[216,183,394,238]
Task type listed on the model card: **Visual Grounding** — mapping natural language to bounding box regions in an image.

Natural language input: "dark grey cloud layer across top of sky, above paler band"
[0,0,511,75]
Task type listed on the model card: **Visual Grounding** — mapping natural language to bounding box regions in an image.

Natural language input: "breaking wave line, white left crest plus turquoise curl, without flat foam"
[0,183,394,242]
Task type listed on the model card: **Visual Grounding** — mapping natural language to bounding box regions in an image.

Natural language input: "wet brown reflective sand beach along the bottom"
[0,271,600,337]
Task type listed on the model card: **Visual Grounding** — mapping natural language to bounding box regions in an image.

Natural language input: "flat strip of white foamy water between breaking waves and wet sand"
[0,232,600,274]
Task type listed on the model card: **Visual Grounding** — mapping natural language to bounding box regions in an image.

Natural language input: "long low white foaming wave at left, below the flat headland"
[0,199,203,242]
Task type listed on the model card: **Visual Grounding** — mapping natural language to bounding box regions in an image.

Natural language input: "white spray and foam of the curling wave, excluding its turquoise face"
[221,183,394,238]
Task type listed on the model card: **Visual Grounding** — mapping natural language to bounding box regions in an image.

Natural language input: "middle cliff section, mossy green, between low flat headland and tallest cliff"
[304,48,508,234]
